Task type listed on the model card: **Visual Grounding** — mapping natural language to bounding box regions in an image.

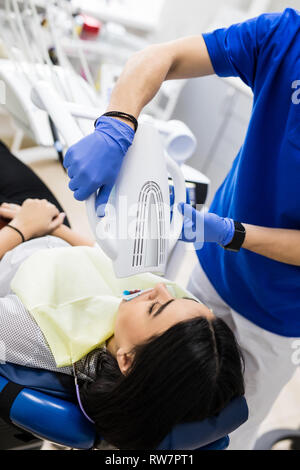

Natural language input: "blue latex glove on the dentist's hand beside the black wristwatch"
[178,203,235,249]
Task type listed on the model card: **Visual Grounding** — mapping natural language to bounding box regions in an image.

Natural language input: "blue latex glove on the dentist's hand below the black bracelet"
[64,116,134,217]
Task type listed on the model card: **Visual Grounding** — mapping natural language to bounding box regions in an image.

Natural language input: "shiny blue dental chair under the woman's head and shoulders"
[0,363,248,450]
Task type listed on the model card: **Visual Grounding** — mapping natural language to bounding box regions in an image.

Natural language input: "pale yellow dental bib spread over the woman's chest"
[11,247,196,367]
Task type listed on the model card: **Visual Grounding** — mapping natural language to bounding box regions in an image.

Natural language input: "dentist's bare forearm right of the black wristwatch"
[243,224,300,266]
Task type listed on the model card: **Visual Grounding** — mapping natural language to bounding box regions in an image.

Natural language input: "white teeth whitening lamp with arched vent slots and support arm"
[32,82,186,278]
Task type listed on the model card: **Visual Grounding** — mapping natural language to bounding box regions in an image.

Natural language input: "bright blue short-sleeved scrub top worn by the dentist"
[197,9,300,337]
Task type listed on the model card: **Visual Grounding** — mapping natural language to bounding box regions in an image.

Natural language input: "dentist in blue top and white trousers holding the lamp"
[65,9,300,449]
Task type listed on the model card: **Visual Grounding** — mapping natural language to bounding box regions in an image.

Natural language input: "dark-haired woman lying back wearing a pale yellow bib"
[0,144,244,450]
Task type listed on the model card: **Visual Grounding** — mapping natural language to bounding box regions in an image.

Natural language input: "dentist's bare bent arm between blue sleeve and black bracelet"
[108,36,214,118]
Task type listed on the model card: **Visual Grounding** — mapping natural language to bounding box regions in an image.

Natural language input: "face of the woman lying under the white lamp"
[114,284,214,352]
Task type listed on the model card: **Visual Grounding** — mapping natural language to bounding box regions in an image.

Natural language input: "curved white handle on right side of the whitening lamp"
[165,153,186,256]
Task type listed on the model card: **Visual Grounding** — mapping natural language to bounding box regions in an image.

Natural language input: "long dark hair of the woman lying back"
[80,317,244,450]
